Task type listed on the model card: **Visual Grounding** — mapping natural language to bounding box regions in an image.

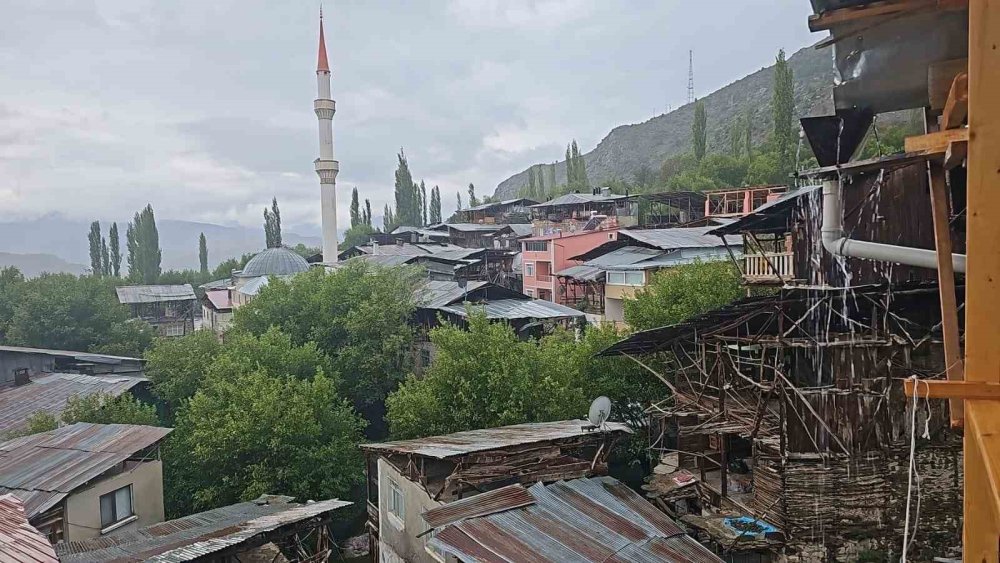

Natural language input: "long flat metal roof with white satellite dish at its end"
[361,420,632,459]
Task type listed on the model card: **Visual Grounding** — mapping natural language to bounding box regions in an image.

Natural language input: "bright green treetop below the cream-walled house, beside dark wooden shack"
[624,260,744,330]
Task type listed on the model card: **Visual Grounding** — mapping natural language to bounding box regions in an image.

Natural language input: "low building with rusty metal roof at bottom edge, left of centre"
[56,495,352,563]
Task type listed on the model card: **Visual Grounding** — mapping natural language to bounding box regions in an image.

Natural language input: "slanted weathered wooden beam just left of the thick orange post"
[928,162,968,428]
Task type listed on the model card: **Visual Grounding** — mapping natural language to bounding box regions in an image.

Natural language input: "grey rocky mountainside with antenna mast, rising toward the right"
[494,47,833,199]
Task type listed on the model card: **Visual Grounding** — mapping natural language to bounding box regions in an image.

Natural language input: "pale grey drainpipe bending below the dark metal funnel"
[820,180,965,274]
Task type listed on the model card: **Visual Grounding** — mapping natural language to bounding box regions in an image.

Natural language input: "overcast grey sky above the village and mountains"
[0,0,820,234]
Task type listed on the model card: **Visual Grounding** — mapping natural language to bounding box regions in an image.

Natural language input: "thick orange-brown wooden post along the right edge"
[962,0,1000,563]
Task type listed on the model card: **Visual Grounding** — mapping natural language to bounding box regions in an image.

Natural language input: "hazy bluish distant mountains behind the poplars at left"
[0,214,322,274]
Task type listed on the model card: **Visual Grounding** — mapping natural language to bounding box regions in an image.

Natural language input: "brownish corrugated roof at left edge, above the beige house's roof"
[0,373,147,439]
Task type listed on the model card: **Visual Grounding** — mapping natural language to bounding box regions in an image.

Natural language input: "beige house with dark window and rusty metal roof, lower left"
[0,422,171,544]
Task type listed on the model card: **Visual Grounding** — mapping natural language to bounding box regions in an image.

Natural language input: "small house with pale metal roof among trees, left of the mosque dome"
[115,283,198,336]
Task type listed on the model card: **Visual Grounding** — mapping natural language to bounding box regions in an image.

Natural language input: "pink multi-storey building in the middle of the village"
[521,230,618,305]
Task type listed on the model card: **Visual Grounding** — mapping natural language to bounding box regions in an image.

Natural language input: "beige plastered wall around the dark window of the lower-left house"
[65,460,164,541]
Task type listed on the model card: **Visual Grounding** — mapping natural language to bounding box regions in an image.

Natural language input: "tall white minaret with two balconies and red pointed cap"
[313,10,340,264]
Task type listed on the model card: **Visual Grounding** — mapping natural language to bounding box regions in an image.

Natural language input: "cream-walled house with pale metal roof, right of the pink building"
[555,227,742,324]
